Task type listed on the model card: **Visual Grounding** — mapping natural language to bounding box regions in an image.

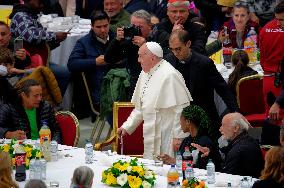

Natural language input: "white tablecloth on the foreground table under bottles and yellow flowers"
[15,145,251,188]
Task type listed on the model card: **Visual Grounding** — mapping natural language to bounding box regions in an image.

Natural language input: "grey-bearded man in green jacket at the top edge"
[104,0,130,32]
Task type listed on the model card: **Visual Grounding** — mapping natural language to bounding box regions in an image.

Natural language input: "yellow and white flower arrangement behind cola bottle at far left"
[0,139,42,169]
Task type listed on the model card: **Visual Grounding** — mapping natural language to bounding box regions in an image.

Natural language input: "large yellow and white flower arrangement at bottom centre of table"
[102,158,156,188]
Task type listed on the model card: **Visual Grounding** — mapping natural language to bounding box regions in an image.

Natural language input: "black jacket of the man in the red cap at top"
[156,15,207,55]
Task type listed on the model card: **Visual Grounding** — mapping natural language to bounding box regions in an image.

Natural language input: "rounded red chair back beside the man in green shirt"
[55,111,80,146]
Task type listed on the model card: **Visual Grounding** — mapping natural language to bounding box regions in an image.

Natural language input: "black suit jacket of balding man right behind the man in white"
[165,51,238,134]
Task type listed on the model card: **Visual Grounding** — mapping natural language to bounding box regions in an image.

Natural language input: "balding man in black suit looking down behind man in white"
[165,29,238,138]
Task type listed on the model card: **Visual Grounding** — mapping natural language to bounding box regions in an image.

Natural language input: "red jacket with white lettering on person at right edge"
[259,19,284,72]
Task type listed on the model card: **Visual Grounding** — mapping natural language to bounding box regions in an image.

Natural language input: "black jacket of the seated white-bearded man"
[221,132,264,178]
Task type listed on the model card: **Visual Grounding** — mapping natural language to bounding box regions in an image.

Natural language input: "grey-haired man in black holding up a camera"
[105,10,167,94]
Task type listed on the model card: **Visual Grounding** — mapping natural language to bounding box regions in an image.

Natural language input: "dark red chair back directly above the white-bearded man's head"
[236,74,265,115]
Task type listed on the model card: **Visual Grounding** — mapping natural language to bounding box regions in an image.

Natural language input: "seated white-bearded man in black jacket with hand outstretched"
[192,112,264,177]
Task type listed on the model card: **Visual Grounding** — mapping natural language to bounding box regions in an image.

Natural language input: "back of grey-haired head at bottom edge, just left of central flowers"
[70,166,94,188]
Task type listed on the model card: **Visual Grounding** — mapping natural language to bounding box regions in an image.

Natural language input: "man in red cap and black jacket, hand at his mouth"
[153,0,207,54]
